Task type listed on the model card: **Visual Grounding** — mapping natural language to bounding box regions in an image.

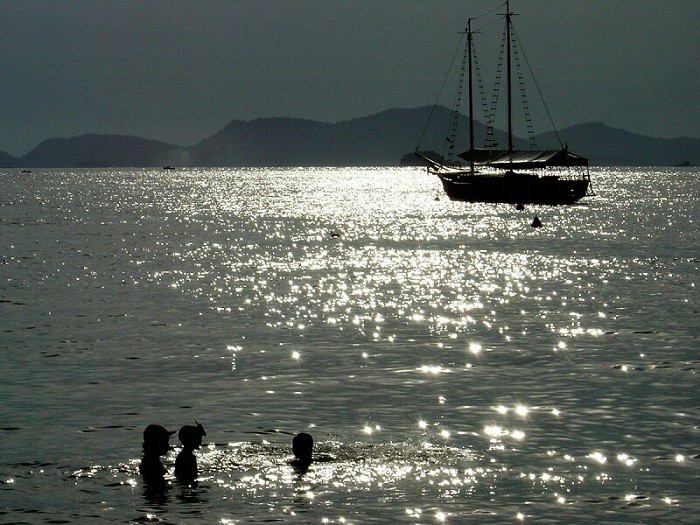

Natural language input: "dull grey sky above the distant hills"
[0,0,700,156]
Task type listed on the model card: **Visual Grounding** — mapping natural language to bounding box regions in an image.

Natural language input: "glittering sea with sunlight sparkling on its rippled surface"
[0,168,700,524]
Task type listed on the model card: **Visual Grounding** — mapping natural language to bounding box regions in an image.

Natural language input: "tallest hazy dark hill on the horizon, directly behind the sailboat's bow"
[192,107,504,166]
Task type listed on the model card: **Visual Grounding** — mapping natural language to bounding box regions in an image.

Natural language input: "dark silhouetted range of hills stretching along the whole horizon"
[0,106,700,168]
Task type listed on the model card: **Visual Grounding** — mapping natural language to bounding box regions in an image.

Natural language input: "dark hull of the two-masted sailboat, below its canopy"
[439,174,590,205]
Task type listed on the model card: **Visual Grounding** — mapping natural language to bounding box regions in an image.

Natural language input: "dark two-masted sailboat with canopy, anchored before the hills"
[416,0,593,205]
